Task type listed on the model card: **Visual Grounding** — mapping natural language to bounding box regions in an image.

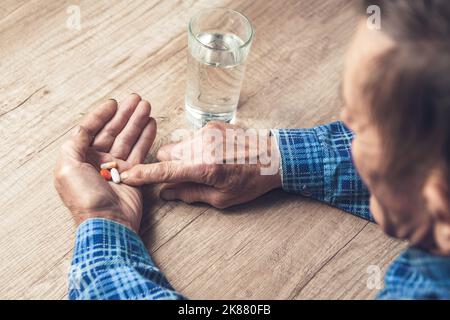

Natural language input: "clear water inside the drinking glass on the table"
[185,33,247,127]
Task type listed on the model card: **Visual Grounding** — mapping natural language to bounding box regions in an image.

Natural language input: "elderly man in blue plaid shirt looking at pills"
[55,0,450,299]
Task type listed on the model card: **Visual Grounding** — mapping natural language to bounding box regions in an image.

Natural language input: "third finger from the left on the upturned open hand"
[110,100,151,159]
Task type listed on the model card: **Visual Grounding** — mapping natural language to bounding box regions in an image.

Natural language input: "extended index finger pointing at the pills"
[120,161,217,186]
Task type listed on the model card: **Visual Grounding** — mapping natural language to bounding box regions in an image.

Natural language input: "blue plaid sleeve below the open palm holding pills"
[69,218,183,300]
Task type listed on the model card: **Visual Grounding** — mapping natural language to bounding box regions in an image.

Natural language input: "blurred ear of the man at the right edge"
[423,170,450,255]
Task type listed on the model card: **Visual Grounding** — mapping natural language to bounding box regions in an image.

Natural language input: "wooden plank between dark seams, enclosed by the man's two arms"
[150,191,367,299]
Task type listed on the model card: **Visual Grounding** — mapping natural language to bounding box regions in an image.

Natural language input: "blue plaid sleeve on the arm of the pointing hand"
[272,121,373,221]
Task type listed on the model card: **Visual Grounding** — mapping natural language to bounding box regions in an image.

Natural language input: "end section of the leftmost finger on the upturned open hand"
[80,100,117,136]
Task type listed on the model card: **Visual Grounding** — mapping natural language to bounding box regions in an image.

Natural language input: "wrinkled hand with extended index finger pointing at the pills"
[121,122,281,208]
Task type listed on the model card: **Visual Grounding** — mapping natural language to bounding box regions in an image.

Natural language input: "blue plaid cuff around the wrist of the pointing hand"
[271,129,324,198]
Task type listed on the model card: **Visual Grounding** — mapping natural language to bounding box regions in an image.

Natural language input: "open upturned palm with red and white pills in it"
[54,94,156,232]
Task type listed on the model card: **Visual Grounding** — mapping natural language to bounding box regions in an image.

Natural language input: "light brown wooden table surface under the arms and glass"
[0,0,405,299]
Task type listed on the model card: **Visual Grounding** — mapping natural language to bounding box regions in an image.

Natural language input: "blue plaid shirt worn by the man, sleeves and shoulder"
[69,122,450,299]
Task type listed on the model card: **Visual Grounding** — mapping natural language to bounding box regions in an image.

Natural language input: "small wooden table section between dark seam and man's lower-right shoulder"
[295,223,407,299]
